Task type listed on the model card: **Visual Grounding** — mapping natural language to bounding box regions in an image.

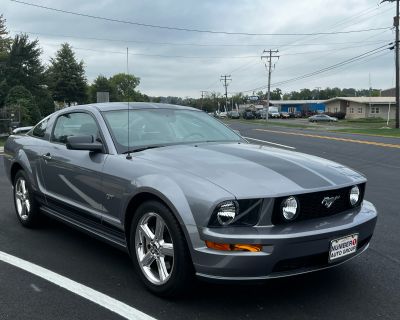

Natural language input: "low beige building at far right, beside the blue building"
[325,97,396,119]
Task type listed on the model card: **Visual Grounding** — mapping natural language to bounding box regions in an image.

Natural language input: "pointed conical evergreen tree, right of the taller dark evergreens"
[47,43,87,106]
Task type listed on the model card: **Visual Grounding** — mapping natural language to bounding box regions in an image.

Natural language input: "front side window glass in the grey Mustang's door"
[51,112,99,143]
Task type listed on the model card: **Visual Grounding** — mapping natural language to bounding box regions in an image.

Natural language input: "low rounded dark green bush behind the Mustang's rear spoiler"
[5,86,41,126]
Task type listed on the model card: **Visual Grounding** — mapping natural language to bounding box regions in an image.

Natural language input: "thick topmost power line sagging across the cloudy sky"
[10,0,391,36]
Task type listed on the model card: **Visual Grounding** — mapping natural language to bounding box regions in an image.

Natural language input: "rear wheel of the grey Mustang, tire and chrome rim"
[13,170,40,228]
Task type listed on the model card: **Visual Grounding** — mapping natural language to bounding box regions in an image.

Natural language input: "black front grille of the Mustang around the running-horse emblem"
[272,183,365,225]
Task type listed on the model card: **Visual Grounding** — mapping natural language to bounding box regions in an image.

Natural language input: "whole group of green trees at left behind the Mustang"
[0,15,149,125]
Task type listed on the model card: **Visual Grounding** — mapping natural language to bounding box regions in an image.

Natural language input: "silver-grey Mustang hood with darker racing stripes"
[137,143,366,198]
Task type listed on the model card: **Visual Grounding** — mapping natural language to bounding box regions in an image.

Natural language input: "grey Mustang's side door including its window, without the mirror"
[41,111,107,225]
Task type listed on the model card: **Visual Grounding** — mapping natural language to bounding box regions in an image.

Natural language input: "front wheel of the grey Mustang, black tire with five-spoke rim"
[129,201,194,297]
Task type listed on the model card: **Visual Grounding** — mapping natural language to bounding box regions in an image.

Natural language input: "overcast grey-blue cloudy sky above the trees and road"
[0,0,395,97]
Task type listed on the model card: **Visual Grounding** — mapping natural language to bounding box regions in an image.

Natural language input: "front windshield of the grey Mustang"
[103,109,243,153]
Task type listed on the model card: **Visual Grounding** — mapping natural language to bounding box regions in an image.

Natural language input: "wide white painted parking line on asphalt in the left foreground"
[0,251,155,320]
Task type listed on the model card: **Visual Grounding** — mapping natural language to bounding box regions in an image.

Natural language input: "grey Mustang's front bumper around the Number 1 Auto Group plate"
[192,201,377,280]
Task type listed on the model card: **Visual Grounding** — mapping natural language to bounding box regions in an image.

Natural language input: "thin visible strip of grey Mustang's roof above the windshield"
[63,102,200,112]
